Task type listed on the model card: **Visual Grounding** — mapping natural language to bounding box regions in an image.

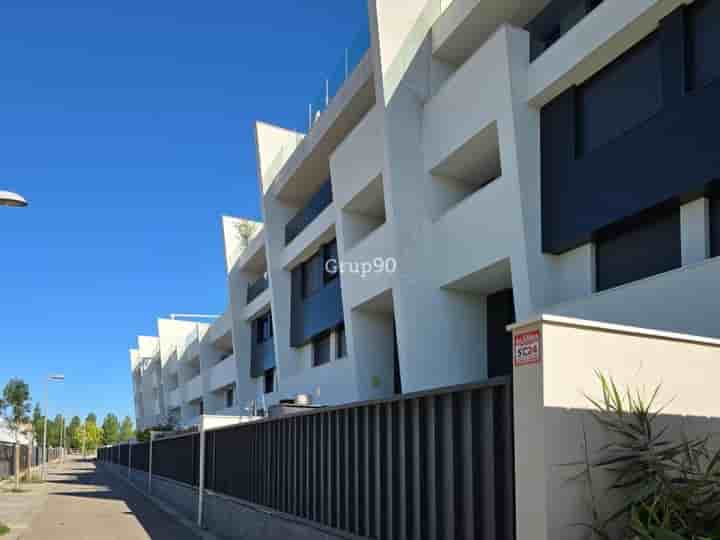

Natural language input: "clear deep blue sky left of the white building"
[0,0,367,426]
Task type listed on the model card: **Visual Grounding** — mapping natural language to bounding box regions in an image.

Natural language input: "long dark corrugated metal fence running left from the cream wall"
[98,377,515,540]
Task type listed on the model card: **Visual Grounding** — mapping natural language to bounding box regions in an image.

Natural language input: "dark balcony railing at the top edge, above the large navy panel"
[525,0,603,62]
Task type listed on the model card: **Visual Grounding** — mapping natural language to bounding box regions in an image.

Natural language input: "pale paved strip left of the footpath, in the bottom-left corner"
[0,463,55,540]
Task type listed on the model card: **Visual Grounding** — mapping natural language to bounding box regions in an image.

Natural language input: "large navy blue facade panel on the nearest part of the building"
[541,0,720,254]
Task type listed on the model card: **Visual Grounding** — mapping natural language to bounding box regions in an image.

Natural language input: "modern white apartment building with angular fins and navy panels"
[131,0,720,426]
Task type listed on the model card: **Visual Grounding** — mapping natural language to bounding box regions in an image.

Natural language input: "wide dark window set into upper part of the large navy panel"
[576,36,662,155]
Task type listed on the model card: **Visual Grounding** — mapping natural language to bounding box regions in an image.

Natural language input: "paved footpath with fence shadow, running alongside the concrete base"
[18,458,199,540]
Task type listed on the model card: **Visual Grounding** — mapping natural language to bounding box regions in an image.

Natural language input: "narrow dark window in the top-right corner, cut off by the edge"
[687,0,720,88]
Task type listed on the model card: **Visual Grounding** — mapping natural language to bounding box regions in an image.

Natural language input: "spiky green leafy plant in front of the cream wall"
[583,373,720,540]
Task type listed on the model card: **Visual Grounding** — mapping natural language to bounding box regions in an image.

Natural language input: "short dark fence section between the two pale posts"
[153,433,200,486]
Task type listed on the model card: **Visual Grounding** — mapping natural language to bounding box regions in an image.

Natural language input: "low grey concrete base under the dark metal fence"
[97,461,360,540]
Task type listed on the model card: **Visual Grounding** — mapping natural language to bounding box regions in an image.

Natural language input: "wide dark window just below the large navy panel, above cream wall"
[595,209,682,291]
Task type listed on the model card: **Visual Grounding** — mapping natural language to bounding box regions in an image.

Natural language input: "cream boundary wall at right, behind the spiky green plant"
[513,316,720,540]
